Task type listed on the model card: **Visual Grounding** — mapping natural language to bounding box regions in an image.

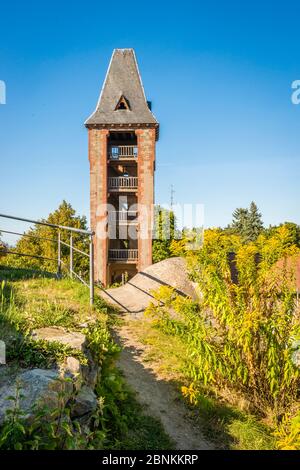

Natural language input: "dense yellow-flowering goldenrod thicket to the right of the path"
[148,224,300,447]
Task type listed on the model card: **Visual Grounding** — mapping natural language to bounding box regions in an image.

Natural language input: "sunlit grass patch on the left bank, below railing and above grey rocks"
[0,269,106,368]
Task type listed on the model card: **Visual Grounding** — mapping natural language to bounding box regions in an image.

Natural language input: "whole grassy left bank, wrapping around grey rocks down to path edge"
[0,268,173,450]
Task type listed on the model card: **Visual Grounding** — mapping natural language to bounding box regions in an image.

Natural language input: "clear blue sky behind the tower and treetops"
[0,0,300,241]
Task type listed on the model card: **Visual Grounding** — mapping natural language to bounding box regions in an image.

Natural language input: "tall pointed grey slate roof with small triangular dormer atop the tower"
[85,49,159,132]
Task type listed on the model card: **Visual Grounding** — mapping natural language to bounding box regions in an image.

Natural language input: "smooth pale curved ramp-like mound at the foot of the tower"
[100,258,196,313]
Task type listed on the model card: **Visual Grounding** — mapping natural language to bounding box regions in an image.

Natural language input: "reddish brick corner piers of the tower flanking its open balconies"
[89,128,155,286]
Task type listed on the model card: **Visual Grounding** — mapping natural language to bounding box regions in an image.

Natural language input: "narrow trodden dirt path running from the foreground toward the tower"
[115,324,214,450]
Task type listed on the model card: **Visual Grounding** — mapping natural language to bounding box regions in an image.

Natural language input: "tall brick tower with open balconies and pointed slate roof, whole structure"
[85,49,159,286]
